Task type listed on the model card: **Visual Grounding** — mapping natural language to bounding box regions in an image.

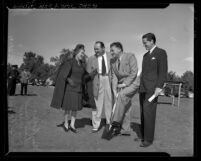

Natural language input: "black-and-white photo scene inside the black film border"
[6,3,194,157]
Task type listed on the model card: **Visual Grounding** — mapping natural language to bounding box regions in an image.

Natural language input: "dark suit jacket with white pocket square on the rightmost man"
[139,47,168,93]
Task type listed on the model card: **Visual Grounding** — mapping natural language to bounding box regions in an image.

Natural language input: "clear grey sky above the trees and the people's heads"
[8,4,194,75]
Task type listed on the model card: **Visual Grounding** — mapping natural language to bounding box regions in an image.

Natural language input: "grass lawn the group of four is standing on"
[8,86,194,156]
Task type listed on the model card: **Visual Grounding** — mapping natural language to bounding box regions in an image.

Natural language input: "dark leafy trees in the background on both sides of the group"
[7,48,194,95]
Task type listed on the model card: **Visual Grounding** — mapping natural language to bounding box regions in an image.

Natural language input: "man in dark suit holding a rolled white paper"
[138,33,168,147]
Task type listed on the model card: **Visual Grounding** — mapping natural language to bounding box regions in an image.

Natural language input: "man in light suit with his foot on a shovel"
[104,42,140,139]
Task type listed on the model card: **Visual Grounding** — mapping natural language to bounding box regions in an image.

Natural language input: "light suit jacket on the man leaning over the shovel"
[111,53,139,95]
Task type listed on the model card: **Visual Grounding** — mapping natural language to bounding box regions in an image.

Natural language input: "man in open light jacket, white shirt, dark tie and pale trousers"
[87,41,112,132]
